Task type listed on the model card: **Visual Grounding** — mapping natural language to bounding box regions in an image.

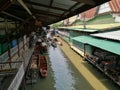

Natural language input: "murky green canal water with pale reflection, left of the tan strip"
[26,47,118,90]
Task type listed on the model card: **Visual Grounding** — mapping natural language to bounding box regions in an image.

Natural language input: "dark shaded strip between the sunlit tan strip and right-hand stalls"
[82,61,120,90]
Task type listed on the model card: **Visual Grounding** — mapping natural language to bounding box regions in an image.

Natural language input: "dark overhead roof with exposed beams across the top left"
[0,0,110,25]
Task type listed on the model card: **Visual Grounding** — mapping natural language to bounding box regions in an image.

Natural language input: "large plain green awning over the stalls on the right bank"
[72,36,120,55]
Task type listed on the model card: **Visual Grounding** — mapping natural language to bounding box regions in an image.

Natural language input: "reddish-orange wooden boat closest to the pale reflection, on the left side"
[40,55,47,77]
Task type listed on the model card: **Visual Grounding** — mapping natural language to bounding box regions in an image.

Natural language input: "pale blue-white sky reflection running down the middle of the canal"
[49,48,75,90]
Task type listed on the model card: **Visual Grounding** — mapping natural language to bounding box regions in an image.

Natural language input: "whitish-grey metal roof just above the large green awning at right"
[91,30,120,41]
